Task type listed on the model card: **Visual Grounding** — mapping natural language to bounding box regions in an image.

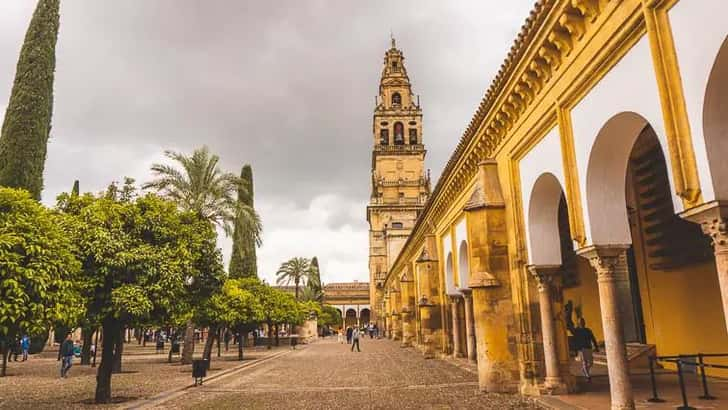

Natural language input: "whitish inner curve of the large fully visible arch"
[586,111,664,245]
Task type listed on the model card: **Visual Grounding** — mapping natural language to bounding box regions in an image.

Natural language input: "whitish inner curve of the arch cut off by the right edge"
[703,37,728,200]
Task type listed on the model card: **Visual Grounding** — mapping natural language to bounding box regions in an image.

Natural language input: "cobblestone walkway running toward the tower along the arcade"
[157,339,538,410]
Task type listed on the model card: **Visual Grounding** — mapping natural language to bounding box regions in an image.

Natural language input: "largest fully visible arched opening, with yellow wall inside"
[586,112,728,372]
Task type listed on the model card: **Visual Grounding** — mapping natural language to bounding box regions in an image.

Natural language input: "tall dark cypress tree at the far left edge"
[0,0,60,199]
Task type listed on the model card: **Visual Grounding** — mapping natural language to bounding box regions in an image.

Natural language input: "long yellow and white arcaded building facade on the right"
[378,0,728,409]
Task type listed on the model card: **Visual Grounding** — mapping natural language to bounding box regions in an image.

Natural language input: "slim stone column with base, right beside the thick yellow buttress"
[528,265,568,394]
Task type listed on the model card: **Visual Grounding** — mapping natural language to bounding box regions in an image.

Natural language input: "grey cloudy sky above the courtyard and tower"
[0,0,533,282]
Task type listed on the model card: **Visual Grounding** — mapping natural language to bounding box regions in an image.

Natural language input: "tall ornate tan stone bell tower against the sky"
[367,38,430,328]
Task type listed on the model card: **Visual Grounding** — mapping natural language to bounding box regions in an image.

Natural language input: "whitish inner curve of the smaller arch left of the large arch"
[528,172,564,265]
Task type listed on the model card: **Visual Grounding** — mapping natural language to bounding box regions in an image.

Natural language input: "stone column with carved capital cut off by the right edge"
[681,201,728,330]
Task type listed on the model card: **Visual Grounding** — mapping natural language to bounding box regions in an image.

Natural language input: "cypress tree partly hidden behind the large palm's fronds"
[228,164,258,278]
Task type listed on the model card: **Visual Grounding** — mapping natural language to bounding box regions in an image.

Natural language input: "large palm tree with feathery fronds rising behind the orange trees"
[143,146,262,363]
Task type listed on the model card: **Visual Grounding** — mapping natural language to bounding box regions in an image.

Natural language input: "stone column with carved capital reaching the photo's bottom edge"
[577,245,635,410]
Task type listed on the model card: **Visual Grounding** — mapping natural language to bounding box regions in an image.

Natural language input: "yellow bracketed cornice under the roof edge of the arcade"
[387,0,618,288]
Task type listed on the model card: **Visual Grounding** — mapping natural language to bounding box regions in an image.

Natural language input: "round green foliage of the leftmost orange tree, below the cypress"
[0,187,83,340]
